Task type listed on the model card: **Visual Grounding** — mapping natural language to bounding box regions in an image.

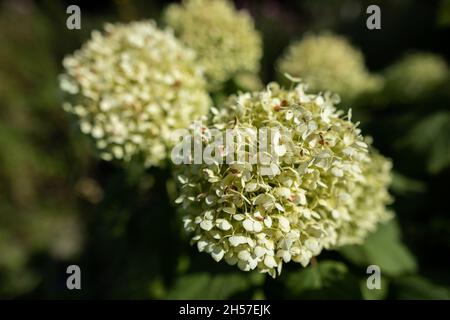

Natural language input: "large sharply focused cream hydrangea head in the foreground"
[177,83,389,277]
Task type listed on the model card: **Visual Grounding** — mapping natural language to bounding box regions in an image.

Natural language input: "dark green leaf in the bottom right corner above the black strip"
[395,276,450,300]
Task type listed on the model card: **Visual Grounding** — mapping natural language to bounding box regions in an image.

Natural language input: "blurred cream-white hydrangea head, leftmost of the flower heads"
[60,21,211,166]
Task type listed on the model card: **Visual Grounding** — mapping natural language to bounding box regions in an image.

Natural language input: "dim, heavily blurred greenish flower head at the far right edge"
[385,53,449,102]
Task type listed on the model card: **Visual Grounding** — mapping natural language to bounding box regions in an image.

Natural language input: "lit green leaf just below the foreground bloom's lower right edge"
[339,221,417,277]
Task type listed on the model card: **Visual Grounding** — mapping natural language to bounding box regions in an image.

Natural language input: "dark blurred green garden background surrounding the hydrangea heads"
[0,0,450,299]
